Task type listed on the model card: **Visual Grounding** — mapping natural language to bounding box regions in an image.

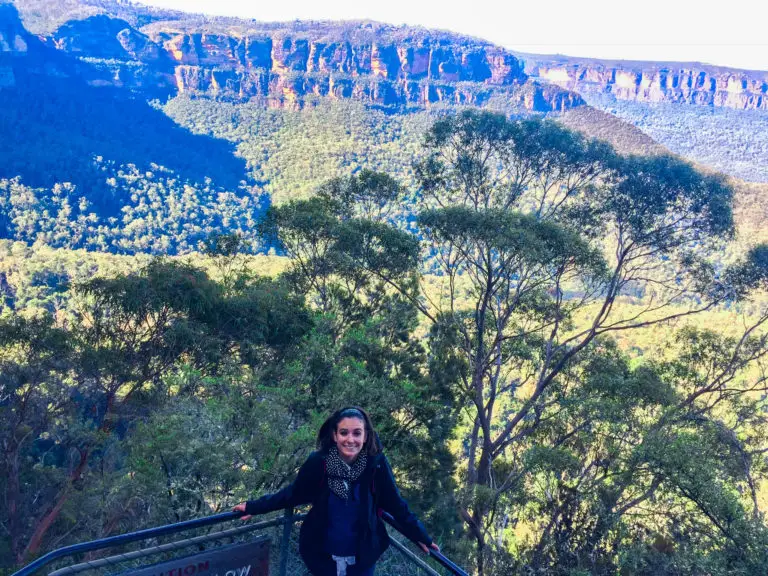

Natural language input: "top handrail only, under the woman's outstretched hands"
[12,509,469,576]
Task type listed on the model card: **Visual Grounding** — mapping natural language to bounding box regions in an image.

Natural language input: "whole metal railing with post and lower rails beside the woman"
[12,509,468,576]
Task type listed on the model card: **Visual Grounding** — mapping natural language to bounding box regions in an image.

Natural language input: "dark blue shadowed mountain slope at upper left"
[0,4,245,187]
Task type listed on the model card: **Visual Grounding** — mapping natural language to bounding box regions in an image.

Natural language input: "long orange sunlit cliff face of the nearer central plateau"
[155,34,532,109]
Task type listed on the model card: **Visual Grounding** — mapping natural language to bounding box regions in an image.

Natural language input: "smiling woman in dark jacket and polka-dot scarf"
[234,408,440,576]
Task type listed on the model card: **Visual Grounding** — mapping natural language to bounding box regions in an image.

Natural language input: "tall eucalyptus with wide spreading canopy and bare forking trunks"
[408,111,763,574]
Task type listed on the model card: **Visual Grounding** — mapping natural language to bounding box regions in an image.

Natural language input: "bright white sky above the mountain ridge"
[139,0,768,70]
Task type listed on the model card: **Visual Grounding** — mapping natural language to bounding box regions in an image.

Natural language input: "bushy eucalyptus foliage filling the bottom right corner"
[510,317,768,574]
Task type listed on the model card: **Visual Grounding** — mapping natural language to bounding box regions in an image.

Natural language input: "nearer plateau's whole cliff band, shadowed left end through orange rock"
[0,4,583,111]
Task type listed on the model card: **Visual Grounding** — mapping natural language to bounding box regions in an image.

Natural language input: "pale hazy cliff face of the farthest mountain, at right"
[526,57,768,110]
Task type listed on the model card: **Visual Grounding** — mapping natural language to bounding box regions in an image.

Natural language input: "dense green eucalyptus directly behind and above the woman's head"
[262,170,460,533]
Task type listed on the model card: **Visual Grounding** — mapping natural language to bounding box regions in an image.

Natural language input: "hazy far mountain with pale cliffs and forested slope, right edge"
[515,53,768,182]
